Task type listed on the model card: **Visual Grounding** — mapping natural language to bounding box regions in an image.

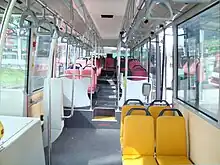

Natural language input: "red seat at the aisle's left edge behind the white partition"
[82,66,97,93]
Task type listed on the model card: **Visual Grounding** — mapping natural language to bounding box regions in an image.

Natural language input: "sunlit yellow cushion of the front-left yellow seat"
[122,156,157,165]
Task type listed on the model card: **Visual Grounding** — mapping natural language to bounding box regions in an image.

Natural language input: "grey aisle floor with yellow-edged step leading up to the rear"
[45,56,122,165]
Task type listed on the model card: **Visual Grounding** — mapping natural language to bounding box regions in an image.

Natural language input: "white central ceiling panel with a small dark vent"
[84,0,128,40]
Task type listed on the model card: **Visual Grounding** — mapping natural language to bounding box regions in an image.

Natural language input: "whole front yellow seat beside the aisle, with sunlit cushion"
[122,110,157,165]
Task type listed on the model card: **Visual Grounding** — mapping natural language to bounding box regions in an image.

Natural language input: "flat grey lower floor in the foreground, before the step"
[46,128,121,165]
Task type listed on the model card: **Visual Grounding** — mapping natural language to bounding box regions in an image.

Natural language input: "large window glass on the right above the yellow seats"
[177,3,220,119]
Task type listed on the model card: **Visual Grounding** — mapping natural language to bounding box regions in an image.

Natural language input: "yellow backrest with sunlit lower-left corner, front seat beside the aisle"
[122,111,154,157]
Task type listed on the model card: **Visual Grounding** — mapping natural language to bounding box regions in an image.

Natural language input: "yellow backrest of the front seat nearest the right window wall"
[156,110,187,156]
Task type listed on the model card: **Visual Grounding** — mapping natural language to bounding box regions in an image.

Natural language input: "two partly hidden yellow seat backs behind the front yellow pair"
[120,99,172,144]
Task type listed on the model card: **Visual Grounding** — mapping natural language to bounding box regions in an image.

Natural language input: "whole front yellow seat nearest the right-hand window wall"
[156,109,192,165]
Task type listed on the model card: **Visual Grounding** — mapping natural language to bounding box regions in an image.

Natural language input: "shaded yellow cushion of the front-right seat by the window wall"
[157,156,193,165]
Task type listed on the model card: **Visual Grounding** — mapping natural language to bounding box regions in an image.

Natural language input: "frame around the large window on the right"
[173,0,220,128]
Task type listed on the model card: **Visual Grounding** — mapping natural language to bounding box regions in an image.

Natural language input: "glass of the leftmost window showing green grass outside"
[0,14,30,89]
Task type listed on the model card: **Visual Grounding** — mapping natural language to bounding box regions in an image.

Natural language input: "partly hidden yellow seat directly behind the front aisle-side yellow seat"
[120,105,145,146]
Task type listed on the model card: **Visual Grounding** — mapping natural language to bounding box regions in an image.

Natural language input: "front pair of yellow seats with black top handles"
[122,108,192,165]
